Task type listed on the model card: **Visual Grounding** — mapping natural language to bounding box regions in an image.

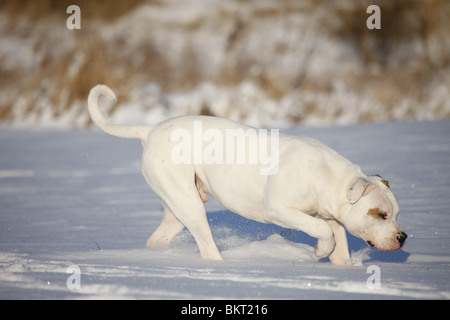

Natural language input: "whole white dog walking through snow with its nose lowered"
[88,85,407,265]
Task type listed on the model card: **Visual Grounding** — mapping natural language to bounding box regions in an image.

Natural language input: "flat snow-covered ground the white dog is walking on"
[0,120,450,299]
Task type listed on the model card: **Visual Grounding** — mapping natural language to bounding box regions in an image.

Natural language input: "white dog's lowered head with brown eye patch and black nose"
[342,176,407,251]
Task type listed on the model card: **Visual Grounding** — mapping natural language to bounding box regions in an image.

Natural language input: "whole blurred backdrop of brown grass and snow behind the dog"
[0,0,450,129]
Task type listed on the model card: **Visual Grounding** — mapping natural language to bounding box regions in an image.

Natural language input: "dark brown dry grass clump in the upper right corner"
[326,0,450,114]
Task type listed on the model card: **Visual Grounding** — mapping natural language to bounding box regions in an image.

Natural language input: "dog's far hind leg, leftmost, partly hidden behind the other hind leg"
[147,208,184,250]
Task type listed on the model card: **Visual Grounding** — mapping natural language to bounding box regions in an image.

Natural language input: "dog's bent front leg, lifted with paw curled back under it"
[264,207,335,258]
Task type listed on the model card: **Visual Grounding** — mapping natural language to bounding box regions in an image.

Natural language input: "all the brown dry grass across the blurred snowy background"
[0,0,450,127]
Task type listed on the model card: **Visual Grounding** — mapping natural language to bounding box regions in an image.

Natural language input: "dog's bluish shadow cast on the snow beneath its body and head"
[208,210,411,263]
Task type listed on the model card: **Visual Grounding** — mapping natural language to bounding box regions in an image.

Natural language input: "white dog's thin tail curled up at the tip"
[88,84,152,143]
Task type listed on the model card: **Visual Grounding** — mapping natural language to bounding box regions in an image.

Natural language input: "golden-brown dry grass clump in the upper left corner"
[0,0,145,121]
